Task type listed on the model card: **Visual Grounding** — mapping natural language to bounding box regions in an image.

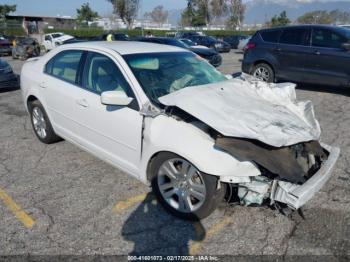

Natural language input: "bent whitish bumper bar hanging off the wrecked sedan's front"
[270,144,340,209]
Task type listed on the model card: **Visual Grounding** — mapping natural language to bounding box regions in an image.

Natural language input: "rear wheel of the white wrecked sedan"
[28,100,61,144]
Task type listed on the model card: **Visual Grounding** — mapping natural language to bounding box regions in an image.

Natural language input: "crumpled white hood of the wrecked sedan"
[159,75,321,147]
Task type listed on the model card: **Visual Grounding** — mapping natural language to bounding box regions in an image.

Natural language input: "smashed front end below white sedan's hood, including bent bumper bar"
[216,137,340,209]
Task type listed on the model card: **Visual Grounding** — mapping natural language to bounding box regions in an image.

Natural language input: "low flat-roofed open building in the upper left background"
[6,15,76,34]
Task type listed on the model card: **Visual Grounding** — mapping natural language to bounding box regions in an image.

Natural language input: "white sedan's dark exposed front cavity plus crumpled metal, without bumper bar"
[215,137,328,206]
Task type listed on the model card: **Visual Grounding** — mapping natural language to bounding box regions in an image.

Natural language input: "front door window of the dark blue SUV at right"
[312,29,348,48]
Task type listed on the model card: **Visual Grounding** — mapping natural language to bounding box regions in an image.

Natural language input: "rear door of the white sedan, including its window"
[39,50,84,140]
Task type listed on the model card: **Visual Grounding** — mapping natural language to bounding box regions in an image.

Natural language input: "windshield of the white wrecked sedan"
[124,52,227,103]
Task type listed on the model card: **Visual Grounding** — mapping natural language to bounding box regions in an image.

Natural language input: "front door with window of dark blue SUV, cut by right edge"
[305,27,350,86]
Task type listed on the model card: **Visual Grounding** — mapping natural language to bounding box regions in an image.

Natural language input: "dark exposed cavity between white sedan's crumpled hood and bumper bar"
[215,137,327,183]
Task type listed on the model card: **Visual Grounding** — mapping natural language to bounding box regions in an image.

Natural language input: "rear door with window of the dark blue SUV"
[274,27,310,82]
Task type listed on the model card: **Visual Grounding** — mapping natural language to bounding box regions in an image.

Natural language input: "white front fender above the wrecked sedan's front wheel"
[141,115,260,181]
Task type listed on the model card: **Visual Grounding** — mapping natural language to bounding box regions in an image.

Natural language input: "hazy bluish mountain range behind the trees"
[169,0,350,25]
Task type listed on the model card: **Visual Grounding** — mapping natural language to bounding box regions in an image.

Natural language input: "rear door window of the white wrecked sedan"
[45,50,83,83]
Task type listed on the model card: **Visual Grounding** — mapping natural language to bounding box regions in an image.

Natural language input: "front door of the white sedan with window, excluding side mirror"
[75,52,143,175]
